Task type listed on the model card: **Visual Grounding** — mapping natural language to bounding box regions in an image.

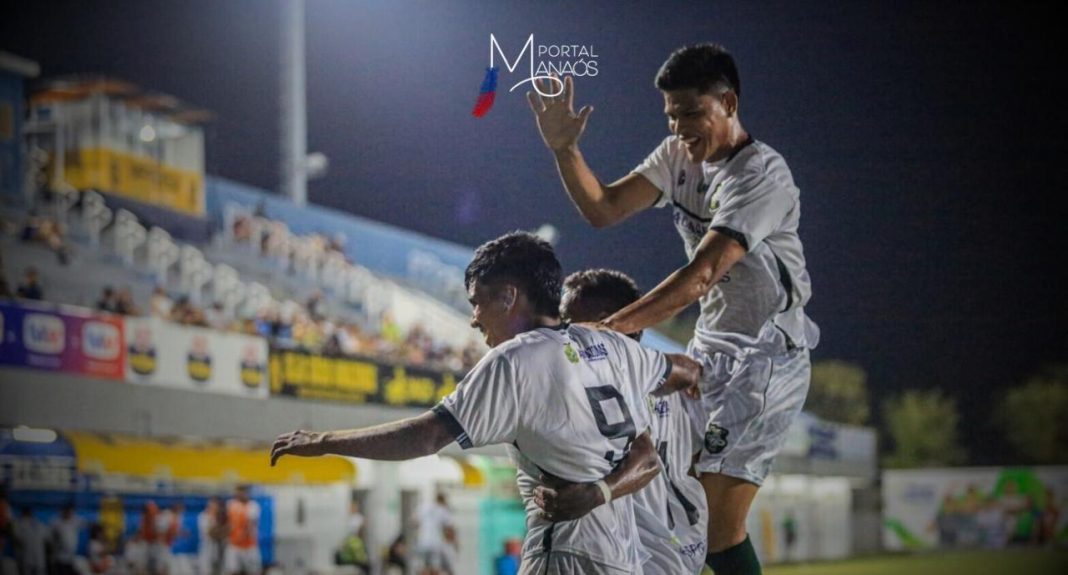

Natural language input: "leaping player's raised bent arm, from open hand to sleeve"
[527,76,660,228]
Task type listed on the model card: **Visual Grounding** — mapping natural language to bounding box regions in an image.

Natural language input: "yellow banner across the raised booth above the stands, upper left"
[63,147,204,217]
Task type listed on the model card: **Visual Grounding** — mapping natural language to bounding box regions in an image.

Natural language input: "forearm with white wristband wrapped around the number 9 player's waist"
[534,432,660,522]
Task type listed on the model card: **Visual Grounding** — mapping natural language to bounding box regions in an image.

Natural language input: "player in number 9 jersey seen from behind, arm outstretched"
[271,232,700,575]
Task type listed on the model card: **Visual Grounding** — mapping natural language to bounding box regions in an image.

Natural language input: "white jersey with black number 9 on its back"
[435,325,671,572]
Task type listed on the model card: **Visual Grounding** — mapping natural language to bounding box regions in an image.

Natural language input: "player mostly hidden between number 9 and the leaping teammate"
[542,269,708,575]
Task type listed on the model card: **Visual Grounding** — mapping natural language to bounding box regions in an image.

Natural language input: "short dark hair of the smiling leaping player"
[656,44,741,97]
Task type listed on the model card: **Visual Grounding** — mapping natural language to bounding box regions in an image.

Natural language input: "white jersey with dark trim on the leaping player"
[634,136,819,357]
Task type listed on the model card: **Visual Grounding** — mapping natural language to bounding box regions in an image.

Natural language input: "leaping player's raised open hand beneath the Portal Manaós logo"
[527,76,594,152]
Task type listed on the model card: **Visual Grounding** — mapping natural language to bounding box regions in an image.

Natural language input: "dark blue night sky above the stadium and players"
[0,0,1068,463]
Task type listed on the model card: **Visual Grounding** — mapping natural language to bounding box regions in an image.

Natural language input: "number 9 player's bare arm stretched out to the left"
[270,411,454,466]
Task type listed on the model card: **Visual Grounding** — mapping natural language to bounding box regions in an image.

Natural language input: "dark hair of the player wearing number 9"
[464,232,564,317]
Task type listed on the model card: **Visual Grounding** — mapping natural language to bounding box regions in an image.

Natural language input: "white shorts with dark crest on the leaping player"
[689,342,812,485]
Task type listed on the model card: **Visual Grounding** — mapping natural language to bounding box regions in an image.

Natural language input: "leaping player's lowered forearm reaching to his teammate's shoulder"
[601,230,745,333]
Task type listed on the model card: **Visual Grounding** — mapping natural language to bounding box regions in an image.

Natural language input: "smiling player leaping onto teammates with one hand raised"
[528,44,819,575]
